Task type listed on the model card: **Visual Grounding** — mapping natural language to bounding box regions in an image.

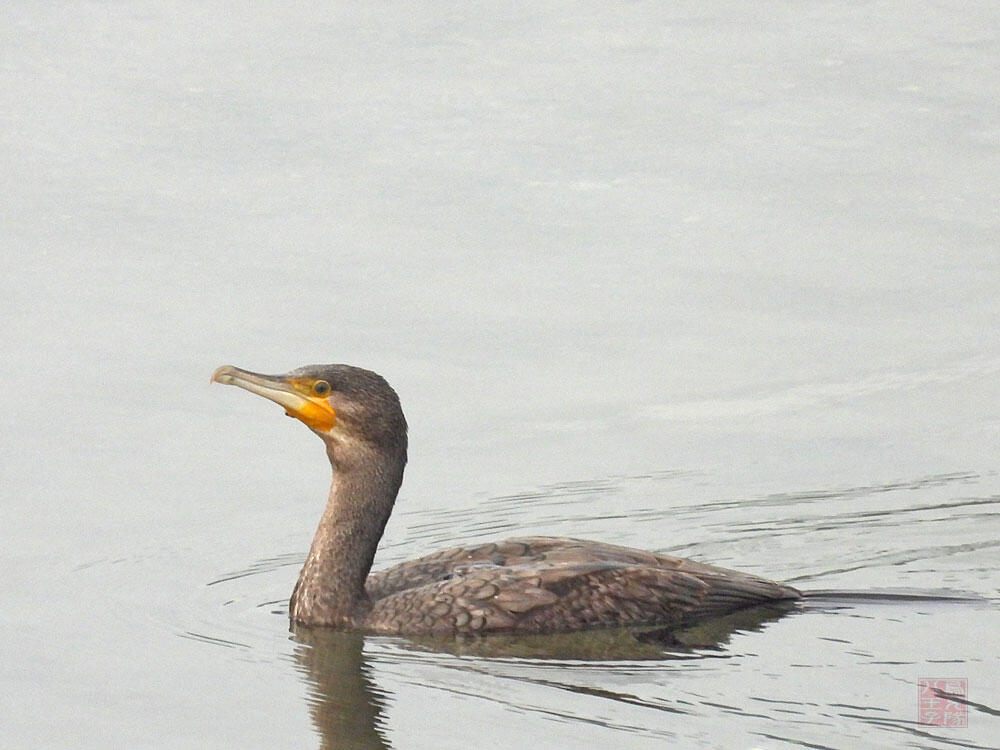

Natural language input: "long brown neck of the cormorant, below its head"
[289,450,406,627]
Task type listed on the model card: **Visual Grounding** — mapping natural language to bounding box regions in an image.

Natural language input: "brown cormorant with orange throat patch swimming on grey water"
[212,365,801,635]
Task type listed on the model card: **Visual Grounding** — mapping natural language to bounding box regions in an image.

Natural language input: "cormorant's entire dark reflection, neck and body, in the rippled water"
[292,602,795,750]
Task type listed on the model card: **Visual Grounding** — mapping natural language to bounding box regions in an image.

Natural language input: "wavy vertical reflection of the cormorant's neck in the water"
[292,626,391,750]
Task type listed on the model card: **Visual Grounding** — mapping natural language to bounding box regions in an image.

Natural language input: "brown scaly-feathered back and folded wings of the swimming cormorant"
[365,537,800,634]
